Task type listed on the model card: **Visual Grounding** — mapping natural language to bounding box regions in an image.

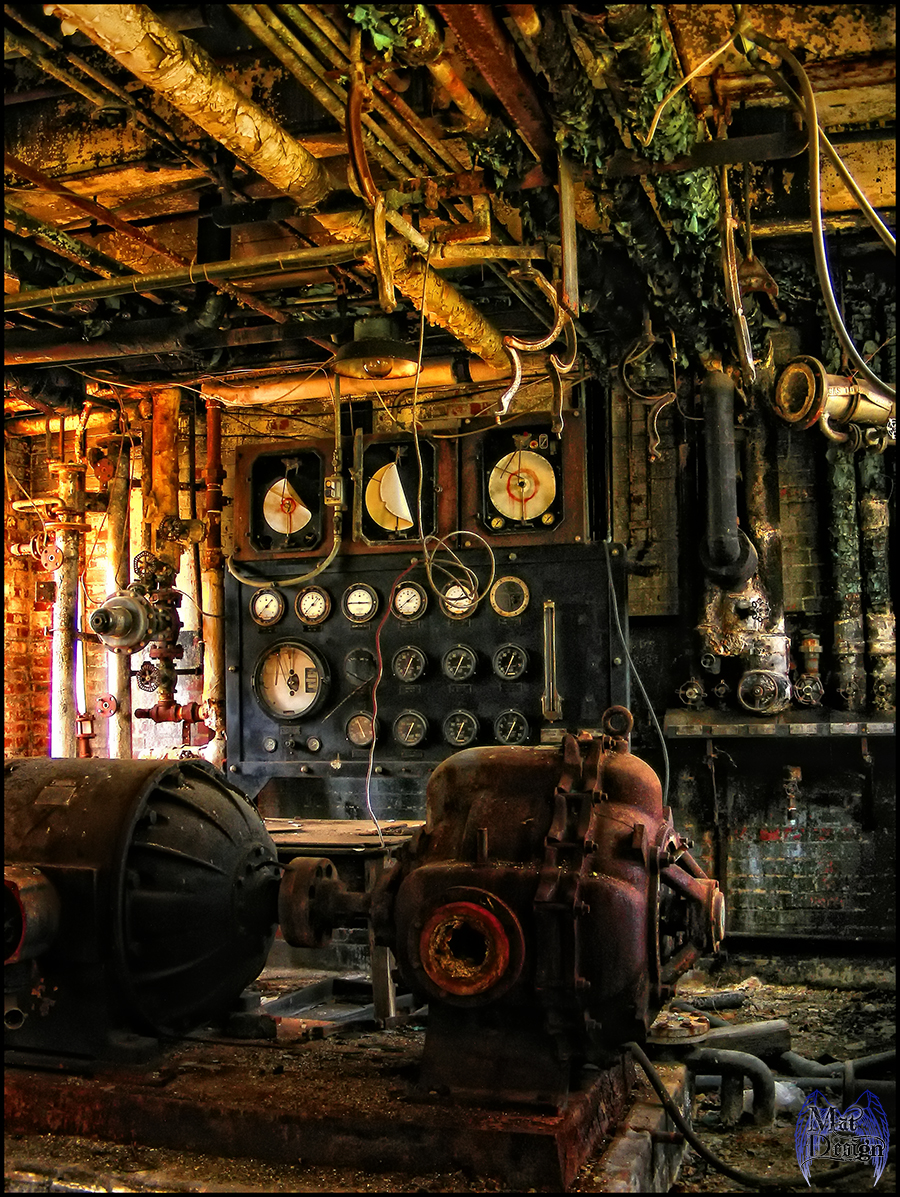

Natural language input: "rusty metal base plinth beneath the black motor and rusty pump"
[5,1035,633,1191]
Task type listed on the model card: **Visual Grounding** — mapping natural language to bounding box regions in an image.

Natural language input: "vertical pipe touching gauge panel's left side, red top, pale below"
[201,395,225,768]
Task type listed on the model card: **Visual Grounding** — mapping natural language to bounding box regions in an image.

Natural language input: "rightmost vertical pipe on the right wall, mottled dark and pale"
[856,452,896,711]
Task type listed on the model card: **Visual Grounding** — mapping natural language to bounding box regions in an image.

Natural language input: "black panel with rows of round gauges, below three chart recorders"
[226,545,628,818]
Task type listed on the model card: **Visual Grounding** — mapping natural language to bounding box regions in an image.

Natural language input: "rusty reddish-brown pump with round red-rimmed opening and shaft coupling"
[279,707,724,1106]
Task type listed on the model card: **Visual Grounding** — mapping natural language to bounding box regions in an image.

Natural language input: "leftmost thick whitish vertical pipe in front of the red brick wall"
[50,459,85,757]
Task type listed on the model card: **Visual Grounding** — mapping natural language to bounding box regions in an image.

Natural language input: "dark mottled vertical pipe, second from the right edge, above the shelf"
[826,444,865,711]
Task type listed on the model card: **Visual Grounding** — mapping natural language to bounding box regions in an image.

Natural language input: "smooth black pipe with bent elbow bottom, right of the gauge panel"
[700,370,758,589]
